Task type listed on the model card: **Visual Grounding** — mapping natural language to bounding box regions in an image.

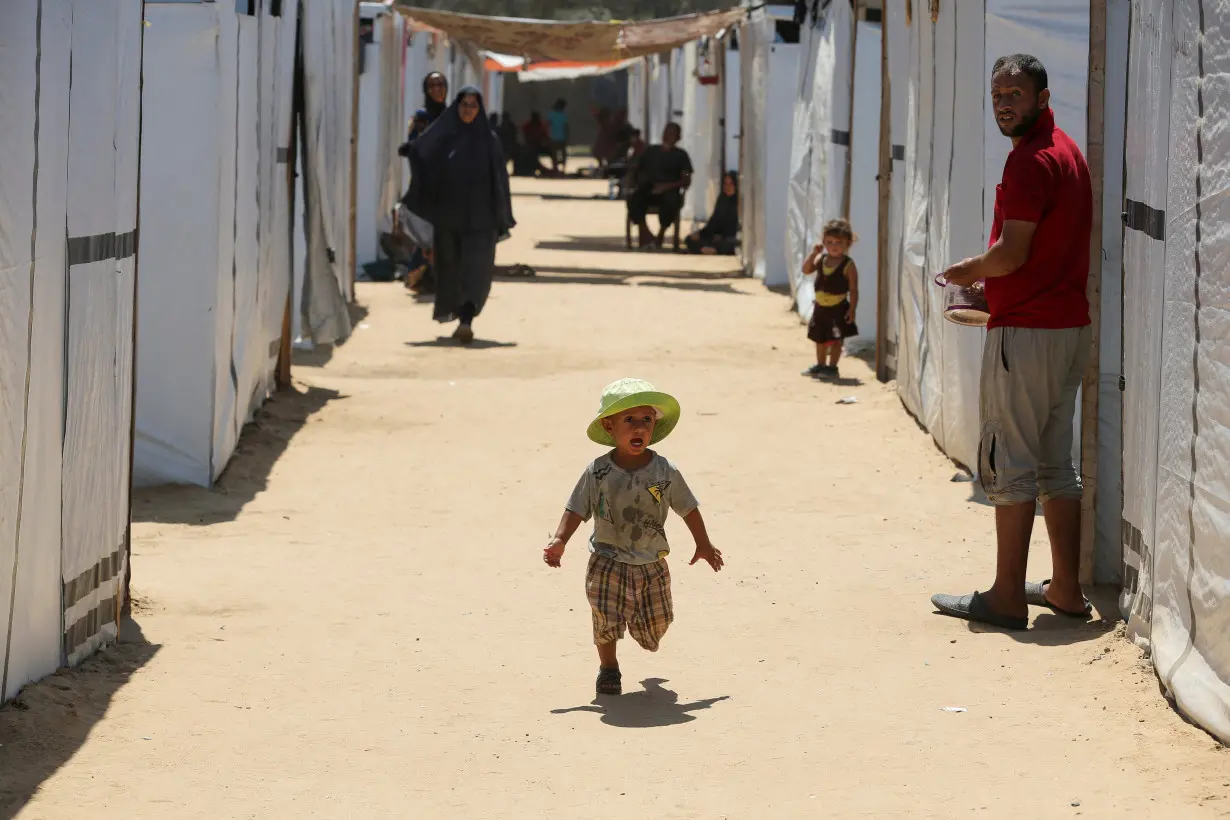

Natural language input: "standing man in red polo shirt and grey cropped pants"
[931,54,1093,629]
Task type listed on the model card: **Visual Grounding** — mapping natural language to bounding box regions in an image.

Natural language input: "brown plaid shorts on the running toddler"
[585,553,675,652]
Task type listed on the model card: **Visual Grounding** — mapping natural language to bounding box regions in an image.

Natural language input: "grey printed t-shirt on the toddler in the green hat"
[565,454,697,564]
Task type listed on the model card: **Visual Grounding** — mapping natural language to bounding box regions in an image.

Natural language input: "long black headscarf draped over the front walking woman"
[403,86,517,236]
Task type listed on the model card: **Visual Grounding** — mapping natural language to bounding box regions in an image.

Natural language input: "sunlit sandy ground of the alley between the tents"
[0,169,1230,820]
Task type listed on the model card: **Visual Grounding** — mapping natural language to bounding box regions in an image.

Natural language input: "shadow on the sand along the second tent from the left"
[133,387,346,526]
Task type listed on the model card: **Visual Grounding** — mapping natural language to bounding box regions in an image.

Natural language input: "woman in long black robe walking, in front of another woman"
[405,86,517,344]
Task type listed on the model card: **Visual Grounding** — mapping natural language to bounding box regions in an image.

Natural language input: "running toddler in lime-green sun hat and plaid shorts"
[542,379,722,695]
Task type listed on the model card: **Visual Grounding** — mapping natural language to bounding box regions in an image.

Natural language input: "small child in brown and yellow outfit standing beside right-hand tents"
[803,219,859,379]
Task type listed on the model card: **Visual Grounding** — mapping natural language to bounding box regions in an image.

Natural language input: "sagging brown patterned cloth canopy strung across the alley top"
[397,2,747,63]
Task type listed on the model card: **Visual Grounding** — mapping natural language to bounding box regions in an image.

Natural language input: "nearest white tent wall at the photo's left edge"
[0,0,141,700]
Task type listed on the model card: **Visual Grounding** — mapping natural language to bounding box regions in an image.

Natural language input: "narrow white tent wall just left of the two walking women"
[354,2,413,269]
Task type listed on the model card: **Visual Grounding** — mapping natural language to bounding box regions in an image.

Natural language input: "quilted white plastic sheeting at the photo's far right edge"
[1108,0,1230,743]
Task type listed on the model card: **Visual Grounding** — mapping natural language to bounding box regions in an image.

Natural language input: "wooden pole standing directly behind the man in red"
[1080,0,1106,584]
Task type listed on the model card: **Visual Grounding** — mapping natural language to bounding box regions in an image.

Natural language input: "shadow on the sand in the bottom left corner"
[0,619,161,818]
